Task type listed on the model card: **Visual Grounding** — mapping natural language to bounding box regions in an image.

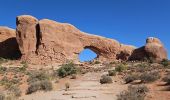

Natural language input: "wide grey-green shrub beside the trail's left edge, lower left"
[27,80,52,94]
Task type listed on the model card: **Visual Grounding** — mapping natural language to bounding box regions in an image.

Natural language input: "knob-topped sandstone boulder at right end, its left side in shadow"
[129,37,167,62]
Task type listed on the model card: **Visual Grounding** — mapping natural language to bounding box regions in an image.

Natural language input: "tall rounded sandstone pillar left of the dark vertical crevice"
[16,15,38,59]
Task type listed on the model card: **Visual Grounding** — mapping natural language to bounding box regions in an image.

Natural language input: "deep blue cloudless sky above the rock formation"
[0,0,170,60]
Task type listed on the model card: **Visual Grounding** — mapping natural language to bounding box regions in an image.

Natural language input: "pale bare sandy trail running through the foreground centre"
[20,73,127,100]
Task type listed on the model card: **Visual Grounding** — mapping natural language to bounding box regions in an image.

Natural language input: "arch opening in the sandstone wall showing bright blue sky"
[79,48,98,62]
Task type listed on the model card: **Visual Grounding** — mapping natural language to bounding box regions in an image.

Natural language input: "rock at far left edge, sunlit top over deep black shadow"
[0,27,21,59]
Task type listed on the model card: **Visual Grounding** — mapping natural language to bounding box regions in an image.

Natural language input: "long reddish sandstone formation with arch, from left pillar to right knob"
[0,15,167,64]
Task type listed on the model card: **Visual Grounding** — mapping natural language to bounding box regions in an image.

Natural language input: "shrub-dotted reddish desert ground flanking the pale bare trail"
[0,57,170,100]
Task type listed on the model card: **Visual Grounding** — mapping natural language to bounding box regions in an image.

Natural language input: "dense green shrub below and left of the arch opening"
[57,63,78,77]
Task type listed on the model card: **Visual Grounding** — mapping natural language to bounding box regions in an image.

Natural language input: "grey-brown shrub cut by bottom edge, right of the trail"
[117,85,149,100]
